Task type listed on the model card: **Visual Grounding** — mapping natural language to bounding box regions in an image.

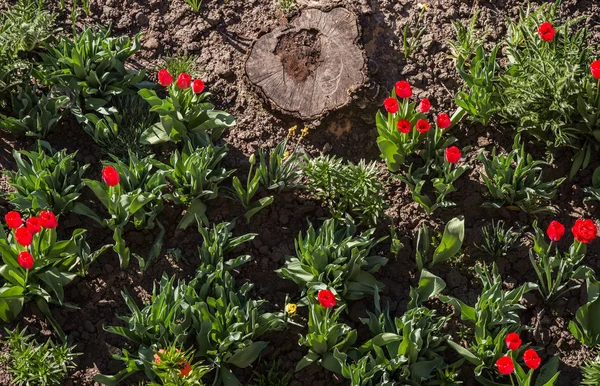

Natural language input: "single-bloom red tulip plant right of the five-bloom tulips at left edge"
[78,153,167,271]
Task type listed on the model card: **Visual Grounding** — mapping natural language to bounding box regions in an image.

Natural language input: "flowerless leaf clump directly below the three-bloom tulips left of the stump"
[165,143,233,229]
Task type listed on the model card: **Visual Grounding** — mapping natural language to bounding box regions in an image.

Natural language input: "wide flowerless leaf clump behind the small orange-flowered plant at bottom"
[94,266,284,386]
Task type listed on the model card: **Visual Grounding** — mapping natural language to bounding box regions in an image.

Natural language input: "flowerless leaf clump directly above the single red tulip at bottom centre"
[277,218,388,300]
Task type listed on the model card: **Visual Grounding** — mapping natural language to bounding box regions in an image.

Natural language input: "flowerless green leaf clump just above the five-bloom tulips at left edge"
[4,141,89,214]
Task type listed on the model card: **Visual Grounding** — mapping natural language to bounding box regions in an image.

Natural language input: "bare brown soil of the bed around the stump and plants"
[0,0,600,386]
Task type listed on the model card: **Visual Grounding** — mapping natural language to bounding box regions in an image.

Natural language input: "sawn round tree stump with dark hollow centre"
[246,7,366,119]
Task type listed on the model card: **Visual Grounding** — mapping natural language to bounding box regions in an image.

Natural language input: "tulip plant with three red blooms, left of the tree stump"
[139,69,235,145]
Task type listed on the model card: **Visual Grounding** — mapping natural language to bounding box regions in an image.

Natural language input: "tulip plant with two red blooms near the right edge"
[529,219,597,301]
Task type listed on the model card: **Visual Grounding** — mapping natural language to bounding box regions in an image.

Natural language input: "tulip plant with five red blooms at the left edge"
[0,211,106,339]
